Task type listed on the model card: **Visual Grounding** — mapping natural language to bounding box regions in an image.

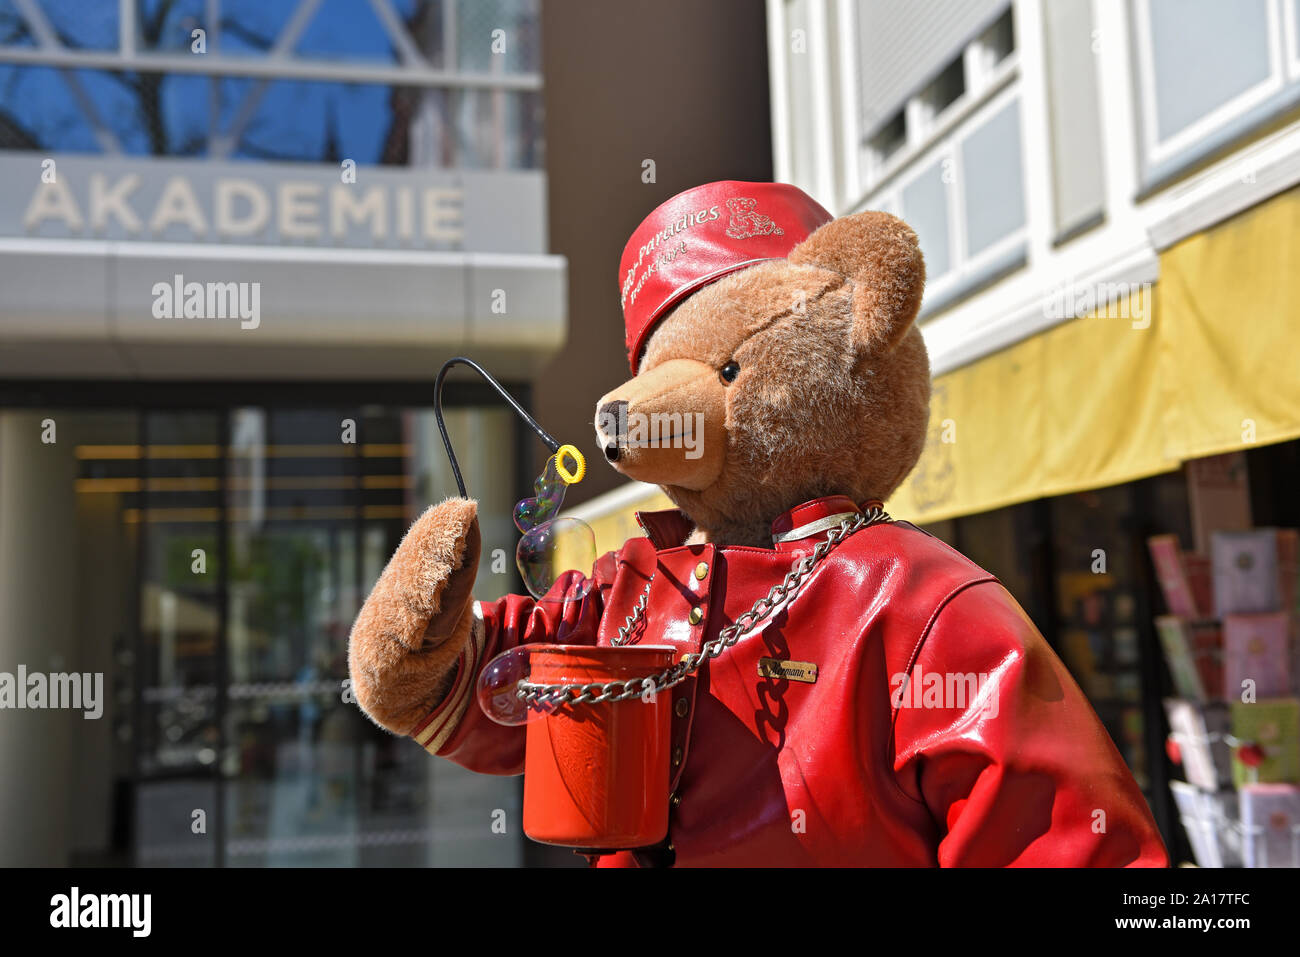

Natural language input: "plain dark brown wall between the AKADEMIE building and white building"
[534,0,772,505]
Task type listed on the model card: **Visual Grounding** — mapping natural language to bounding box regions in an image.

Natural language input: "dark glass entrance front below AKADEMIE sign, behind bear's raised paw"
[49,390,527,866]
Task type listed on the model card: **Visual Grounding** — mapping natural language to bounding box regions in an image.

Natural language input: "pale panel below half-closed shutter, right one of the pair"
[961,100,1024,256]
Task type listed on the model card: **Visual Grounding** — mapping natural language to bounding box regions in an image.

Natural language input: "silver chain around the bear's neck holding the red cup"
[517,506,893,710]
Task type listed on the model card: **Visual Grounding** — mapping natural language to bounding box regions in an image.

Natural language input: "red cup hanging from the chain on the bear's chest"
[524,645,677,850]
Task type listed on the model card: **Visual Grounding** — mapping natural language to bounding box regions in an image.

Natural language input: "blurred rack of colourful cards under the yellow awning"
[1148,528,1300,867]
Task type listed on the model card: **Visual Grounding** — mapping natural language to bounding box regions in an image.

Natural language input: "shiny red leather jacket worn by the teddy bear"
[412,495,1167,866]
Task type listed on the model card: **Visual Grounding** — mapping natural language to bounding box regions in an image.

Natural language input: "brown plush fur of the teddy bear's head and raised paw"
[348,212,930,733]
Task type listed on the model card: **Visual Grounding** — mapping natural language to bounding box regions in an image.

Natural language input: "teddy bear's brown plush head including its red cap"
[595,182,930,547]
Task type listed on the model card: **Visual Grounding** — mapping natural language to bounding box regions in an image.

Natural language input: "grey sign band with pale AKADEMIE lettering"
[0,151,546,254]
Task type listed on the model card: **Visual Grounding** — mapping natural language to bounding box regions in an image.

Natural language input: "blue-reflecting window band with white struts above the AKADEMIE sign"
[0,0,543,169]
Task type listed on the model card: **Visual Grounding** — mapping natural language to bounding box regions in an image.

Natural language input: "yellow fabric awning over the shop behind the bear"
[887,179,1300,523]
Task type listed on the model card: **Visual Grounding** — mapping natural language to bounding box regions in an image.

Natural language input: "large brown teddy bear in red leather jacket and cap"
[348,181,1167,866]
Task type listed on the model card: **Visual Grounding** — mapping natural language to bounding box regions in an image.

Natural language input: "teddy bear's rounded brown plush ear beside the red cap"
[789,212,926,351]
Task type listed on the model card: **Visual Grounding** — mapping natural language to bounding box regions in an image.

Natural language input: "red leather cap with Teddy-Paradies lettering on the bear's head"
[619,179,833,374]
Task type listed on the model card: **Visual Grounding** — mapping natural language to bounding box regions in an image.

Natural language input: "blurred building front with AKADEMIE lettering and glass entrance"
[0,0,567,866]
